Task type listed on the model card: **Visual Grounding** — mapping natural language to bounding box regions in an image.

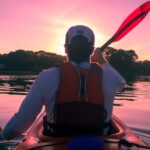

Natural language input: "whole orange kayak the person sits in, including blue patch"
[17,113,147,150]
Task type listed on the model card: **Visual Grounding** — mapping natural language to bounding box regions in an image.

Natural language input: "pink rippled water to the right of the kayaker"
[114,76,150,143]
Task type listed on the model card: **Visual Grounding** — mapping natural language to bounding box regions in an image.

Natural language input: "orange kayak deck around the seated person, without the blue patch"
[17,113,146,150]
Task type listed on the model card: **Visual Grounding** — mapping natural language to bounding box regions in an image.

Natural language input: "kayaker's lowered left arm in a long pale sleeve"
[0,74,43,140]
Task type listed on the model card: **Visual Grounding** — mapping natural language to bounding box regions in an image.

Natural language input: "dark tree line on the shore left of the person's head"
[0,49,65,72]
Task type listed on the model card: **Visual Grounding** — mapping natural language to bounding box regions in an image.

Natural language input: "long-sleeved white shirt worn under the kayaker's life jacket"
[0,62,126,140]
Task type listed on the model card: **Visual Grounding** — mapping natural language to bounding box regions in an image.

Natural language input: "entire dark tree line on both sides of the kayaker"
[0,47,150,76]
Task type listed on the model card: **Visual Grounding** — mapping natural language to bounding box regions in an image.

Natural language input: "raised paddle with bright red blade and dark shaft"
[100,1,150,52]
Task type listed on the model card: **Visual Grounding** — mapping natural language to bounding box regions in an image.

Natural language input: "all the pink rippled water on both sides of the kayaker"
[0,75,150,149]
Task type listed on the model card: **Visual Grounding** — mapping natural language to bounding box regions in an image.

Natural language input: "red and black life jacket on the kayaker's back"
[54,62,106,132]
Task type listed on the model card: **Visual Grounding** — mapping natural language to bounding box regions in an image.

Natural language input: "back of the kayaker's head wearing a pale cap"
[65,25,94,63]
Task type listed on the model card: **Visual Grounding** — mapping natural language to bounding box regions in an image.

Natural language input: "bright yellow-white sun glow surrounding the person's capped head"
[49,20,108,55]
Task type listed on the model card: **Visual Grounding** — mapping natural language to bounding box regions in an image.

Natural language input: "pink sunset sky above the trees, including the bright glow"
[0,0,150,60]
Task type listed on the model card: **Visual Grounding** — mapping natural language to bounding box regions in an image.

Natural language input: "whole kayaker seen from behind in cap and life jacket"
[0,25,125,140]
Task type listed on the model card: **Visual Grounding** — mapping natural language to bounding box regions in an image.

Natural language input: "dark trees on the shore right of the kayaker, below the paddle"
[105,47,150,76]
